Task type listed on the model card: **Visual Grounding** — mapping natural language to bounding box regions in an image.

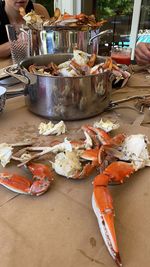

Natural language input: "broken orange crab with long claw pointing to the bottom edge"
[49,127,150,266]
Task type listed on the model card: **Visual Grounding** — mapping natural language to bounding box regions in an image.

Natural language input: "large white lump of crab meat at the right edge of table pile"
[122,134,150,170]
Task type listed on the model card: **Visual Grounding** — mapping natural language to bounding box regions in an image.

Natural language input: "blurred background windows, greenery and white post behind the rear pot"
[35,0,150,56]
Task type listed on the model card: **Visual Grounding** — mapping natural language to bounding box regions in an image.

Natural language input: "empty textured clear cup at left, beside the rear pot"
[6,24,30,64]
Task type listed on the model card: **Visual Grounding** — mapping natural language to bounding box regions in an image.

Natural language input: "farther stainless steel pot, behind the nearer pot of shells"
[30,26,111,55]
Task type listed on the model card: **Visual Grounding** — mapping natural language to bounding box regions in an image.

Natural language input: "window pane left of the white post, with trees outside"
[95,0,134,55]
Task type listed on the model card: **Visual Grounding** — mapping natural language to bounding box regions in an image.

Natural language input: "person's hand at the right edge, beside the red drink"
[135,43,150,65]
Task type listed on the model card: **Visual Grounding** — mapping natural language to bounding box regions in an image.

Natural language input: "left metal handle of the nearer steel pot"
[5,65,30,85]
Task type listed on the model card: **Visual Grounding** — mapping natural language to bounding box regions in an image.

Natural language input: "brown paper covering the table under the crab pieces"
[0,60,150,267]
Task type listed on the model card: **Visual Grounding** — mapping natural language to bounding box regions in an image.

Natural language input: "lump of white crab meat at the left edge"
[0,143,13,167]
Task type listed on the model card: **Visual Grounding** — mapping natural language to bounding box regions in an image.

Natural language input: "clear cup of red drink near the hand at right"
[111,46,131,65]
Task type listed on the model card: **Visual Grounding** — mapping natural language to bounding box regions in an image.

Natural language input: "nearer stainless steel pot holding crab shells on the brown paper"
[4,54,112,120]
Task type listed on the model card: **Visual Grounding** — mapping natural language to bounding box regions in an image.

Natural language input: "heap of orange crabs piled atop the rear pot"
[19,7,106,30]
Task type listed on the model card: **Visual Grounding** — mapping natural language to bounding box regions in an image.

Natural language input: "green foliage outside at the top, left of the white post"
[96,0,134,19]
